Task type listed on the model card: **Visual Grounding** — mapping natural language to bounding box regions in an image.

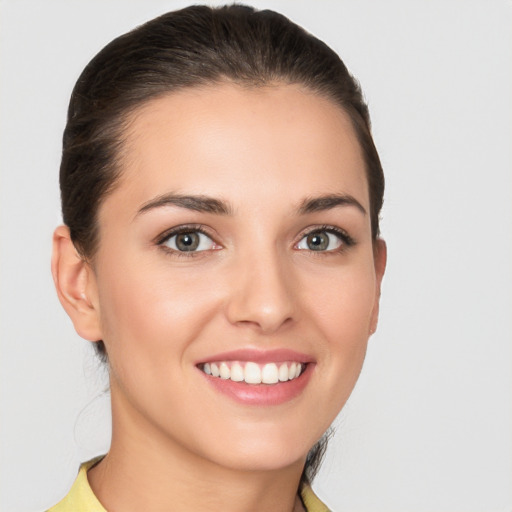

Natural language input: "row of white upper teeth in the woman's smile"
[200,361,304,384]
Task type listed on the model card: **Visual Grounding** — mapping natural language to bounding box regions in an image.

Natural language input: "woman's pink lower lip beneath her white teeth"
[199,363,314,405]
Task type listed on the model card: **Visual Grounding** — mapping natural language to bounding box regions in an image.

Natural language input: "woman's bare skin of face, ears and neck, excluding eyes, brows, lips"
[52,84,386,512]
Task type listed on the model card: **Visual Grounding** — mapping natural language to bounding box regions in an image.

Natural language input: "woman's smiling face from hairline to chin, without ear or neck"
[88,84,385,469]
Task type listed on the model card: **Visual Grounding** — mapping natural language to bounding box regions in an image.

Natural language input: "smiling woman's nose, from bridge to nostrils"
[227,252,297,334]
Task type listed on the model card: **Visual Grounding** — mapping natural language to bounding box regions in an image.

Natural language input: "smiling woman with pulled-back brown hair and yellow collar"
[51,6,386,512]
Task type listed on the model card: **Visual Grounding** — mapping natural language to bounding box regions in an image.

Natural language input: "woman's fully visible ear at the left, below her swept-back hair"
[52,226,102,341]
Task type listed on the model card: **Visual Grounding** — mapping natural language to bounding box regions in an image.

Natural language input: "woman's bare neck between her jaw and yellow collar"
[88,390,304,512]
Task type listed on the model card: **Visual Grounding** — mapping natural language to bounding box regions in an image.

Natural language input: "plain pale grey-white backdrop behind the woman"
[0,0,512,512]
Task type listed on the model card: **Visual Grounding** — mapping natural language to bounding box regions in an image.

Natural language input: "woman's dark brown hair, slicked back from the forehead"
[60,5,384,482]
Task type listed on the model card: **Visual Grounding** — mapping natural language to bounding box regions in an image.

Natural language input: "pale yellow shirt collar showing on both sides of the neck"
[47,459,329,512]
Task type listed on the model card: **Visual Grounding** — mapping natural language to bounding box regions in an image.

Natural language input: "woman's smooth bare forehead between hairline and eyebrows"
[107,84,368,216]
